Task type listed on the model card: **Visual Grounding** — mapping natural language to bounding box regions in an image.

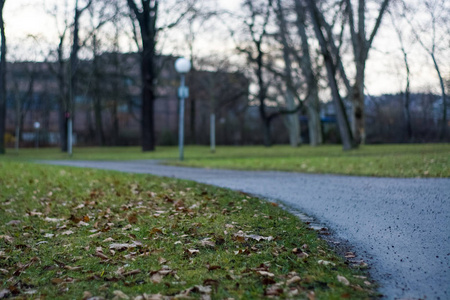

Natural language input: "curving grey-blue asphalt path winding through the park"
[45,160,450,299]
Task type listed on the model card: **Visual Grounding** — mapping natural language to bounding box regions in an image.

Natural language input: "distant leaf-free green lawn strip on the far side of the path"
[0,144,450,177]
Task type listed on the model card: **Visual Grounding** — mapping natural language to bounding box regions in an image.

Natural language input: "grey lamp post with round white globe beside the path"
[175,57,191,160]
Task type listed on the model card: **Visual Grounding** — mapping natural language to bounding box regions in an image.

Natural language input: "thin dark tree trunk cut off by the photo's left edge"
[0,0,6,154]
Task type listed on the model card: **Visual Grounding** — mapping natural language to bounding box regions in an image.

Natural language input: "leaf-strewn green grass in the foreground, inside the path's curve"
[0,163,376,299]
